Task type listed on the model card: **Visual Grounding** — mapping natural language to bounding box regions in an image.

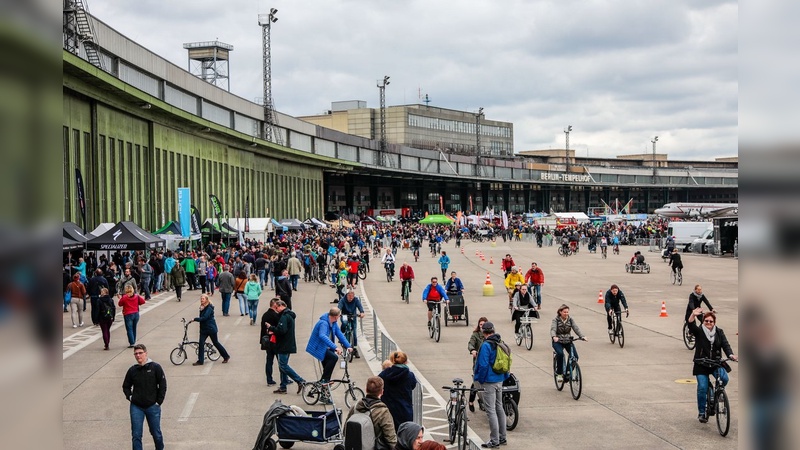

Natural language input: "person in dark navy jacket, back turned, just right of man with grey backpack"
[378,351,417,430]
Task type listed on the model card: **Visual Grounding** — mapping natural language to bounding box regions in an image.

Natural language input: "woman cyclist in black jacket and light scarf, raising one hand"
[689,307,738,423]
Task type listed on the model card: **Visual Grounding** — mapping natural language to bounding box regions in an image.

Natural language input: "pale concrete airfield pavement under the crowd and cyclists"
[63,239,741,449]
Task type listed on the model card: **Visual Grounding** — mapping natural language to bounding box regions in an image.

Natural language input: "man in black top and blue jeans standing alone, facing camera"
[122,344,167,450]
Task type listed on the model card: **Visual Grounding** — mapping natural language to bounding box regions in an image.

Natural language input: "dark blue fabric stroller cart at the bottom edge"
[253,400,344,450]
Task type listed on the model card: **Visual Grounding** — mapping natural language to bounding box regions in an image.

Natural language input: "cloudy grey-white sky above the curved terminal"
[88,0,739,160]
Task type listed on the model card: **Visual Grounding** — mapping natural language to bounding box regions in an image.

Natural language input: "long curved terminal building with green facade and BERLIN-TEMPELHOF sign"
[63,10,738,230]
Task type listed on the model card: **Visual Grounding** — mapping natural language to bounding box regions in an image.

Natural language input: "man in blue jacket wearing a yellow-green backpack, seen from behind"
[474,322,508,448]
